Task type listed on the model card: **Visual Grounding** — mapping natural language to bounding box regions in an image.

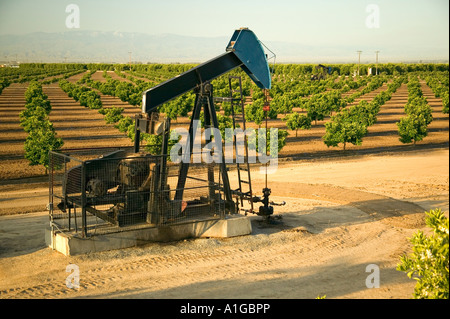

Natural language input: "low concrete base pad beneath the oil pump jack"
[45,215,252,256]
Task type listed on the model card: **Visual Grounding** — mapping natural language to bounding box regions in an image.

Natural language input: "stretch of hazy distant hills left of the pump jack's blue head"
[0,31,228,63]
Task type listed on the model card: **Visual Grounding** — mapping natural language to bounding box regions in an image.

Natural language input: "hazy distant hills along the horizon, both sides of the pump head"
[0,30,448,63]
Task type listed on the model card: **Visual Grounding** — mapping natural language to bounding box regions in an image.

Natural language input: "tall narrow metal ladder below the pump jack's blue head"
[228,75,253,215]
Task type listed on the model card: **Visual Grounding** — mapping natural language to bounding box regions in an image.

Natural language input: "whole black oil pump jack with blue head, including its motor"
[58,28,284,226]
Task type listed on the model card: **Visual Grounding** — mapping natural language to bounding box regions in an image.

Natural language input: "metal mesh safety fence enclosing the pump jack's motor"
[49,149,227,237]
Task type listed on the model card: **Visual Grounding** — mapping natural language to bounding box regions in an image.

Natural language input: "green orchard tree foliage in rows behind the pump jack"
[10,63,449,165]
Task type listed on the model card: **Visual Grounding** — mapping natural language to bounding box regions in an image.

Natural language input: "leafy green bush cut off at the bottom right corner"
[397,209,449,299]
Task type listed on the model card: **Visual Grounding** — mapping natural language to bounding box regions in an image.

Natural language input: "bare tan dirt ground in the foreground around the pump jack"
[0,148,449,299]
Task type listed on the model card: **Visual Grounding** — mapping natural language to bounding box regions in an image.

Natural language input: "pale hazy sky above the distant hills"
[0,0,449,61]
